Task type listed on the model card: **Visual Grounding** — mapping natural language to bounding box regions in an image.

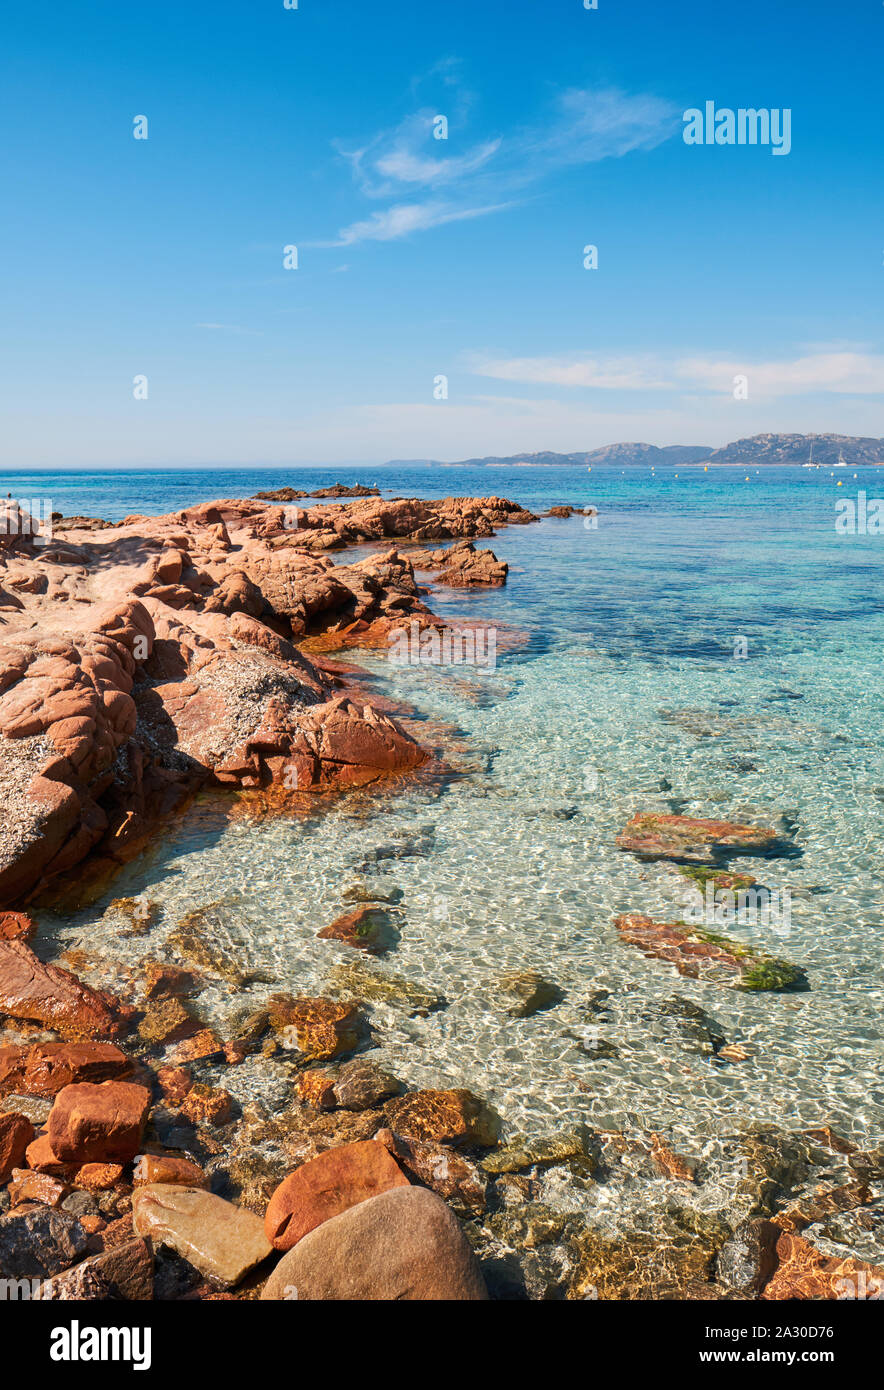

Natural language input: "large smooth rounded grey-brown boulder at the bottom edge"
[261,1187,488,1302]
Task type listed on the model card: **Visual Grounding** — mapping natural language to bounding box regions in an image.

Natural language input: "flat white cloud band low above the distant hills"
[471,352,884,396]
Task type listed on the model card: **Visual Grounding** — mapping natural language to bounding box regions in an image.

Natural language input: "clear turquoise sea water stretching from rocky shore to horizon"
[22,468,884,1173]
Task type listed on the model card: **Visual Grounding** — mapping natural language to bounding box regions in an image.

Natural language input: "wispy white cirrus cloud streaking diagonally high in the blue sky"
[322,88,678,246]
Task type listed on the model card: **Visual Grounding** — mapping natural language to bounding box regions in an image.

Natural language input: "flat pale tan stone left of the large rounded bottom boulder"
[132,1183,272,1289]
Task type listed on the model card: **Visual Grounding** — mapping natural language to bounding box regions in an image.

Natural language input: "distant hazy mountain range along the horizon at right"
[392,434,884,468]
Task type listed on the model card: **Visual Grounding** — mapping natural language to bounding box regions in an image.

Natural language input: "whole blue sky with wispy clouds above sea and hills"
[0,0,884,467]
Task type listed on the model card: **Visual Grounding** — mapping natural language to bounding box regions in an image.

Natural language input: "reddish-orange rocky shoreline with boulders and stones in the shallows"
[0,489,884,1301]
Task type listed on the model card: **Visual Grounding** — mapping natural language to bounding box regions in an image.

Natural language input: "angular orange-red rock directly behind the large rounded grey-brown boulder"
[264,1140,409,1250]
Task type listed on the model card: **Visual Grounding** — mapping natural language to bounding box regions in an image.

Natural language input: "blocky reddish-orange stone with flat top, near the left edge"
[49,1081,150,1163]
